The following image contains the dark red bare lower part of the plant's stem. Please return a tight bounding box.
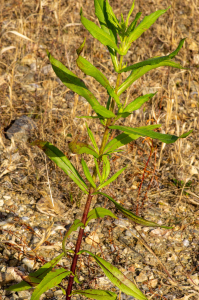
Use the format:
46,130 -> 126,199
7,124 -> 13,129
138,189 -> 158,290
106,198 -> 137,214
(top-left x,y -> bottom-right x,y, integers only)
66,190 -> 93,300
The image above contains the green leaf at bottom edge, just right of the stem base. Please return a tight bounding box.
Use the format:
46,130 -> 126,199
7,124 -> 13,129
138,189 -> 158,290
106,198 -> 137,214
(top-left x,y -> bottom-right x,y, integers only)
72,289 -> 117,300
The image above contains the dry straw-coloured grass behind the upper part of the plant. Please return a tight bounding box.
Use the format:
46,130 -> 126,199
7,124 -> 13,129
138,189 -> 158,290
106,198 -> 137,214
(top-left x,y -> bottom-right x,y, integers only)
0,0 -> 199,300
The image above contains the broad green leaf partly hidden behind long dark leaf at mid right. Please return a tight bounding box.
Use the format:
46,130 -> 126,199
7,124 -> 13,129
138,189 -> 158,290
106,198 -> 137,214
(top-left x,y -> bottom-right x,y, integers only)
104,124 -> 161,154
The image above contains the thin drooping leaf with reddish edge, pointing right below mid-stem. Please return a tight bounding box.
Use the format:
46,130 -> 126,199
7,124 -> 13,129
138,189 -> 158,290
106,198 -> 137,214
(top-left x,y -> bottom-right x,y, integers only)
98,192 -> 172,229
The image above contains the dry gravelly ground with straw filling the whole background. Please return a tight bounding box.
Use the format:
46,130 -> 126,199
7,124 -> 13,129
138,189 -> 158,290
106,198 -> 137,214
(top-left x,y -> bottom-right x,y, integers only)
0,0 -> 199,300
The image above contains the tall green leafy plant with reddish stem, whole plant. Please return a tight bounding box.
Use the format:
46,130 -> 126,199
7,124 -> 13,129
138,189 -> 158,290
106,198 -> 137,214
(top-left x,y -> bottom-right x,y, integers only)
9,0 -> 191,300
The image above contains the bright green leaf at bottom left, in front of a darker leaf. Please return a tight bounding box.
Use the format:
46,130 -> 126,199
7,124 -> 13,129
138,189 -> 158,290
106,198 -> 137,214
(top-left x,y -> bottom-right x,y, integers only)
31,268 -> 72,300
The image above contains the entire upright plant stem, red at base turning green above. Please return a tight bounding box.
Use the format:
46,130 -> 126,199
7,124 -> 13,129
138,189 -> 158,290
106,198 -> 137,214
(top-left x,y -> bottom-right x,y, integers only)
66,56 -> 123,300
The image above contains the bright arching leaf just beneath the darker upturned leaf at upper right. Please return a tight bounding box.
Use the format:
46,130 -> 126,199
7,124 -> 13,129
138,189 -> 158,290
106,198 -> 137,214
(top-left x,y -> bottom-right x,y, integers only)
117,60 -> 186,96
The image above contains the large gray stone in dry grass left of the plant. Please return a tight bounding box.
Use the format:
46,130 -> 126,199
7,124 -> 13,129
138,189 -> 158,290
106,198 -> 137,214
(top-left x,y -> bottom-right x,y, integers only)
6,116 -> 37,142
